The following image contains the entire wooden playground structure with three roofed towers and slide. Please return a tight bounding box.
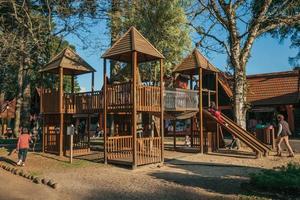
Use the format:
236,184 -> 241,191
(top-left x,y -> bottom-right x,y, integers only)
40,27 -> 270,168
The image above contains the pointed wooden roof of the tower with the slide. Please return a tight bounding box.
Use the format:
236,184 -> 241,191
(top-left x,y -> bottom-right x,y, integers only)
173,48 -> 219,75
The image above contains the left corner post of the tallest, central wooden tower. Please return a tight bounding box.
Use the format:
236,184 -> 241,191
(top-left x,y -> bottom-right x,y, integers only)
103,59 -> 107,164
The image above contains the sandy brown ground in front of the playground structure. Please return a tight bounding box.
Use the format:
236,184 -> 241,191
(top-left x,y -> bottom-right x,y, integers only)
0,145 -> 300,200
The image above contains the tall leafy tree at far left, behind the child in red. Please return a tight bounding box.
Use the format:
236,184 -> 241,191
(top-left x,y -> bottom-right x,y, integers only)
0,0 -> 106,135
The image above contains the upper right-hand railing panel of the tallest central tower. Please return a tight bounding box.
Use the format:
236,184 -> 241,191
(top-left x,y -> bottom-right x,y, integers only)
137,86 -> 160,112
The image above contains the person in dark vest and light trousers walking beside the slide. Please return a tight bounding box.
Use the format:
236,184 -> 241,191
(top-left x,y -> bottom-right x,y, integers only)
277,115 -> 294,157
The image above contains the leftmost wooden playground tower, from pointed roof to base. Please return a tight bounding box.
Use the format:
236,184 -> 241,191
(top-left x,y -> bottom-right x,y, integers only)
40,48 -> 96,155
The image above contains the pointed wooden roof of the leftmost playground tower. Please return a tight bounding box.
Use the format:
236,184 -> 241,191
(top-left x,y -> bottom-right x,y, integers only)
40,47 -> 96,75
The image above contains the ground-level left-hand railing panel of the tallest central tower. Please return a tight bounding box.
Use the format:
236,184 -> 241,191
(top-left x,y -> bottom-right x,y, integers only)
106,135 -> 133,161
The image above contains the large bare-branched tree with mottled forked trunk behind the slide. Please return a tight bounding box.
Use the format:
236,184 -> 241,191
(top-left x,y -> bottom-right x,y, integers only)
189,0 -> 300,128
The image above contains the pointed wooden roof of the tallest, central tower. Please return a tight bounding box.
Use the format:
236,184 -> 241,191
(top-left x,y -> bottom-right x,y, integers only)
102,26 -> 165,63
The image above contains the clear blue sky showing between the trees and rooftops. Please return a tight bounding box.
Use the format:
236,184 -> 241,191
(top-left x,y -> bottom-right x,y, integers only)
66,23 -> 297,92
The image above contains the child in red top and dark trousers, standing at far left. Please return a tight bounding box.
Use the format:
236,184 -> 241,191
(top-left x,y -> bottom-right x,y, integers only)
17,128 -> 31,166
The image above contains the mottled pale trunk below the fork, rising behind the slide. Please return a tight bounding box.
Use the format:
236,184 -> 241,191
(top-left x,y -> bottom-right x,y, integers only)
233,69 -> 247,129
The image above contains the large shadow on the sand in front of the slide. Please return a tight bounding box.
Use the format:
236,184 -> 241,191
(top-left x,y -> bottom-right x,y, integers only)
149,159 -> 270,198
